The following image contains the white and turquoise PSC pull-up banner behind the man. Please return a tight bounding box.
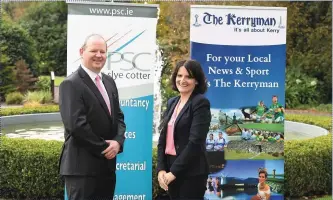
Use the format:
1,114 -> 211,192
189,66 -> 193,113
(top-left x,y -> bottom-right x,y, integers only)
67,2 -> 158,200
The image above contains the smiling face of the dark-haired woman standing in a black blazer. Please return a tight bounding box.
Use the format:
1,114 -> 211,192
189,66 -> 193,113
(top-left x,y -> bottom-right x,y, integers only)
176,66 -> 197,94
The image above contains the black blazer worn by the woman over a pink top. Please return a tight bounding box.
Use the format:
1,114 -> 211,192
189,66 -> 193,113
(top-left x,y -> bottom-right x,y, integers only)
157,93 -> 211,178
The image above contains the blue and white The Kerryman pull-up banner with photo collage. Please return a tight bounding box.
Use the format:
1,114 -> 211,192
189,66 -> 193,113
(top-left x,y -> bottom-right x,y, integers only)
190,5 -> 287,200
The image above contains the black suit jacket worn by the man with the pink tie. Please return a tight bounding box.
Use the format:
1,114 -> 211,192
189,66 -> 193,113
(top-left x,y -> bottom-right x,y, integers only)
59,67 -> 126,176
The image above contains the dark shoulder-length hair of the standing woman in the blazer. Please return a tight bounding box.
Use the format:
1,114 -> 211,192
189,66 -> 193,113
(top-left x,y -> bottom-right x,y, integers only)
171,60 -> 207,94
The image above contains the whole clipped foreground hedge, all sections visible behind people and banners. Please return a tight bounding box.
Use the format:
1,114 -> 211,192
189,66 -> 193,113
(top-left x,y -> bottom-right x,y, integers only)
0,134 -> 332,199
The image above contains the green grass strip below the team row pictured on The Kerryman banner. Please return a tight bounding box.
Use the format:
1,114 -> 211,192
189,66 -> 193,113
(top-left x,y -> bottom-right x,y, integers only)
224,148 -> 284,160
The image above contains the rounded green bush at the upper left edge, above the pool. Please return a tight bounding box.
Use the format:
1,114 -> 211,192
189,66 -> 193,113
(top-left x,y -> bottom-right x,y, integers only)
0,12 -> 38,74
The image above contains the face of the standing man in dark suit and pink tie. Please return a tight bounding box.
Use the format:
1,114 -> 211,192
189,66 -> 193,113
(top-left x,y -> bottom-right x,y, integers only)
80,37 -> 106,73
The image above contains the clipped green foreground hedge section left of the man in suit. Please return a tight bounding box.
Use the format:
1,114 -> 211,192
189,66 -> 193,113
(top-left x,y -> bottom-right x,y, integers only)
0,136 -> 63,199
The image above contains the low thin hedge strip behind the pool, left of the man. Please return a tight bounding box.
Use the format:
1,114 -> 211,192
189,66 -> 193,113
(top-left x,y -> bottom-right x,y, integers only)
0,105 -> 59,116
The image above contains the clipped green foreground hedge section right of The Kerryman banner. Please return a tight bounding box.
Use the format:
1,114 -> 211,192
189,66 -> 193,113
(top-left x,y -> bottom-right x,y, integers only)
284,134 -> 332,197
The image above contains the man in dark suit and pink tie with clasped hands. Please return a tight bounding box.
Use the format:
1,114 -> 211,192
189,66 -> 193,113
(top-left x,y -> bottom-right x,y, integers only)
59,34 -> 126,200
